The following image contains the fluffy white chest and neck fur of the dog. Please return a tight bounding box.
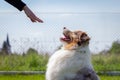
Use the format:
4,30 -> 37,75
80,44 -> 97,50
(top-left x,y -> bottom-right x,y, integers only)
46,46 -> 93,80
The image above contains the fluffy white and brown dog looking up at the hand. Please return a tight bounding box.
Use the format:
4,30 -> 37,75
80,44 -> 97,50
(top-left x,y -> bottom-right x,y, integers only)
46,27 -> 99,80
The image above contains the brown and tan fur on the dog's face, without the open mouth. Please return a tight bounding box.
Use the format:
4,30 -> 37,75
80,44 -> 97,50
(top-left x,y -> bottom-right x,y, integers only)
63,28 -> 90,50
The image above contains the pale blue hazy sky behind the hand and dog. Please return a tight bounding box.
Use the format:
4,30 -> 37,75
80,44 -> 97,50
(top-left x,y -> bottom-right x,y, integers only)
0,0 -> 120,53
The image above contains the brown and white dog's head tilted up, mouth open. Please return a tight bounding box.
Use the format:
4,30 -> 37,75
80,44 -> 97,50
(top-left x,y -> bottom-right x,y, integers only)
60,27 -> 90,49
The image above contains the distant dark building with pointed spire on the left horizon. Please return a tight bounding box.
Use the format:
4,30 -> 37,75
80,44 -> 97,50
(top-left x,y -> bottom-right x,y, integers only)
2,34 -> 11,54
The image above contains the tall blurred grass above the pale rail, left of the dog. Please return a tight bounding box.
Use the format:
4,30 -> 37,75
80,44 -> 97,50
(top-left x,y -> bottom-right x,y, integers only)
0,53 -> 48,71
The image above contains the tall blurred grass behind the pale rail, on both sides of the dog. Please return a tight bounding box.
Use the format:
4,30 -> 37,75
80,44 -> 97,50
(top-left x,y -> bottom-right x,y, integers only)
0,53 -> 120,71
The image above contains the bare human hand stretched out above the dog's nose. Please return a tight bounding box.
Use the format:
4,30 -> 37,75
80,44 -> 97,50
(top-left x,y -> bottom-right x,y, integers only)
23,6 -> 43,23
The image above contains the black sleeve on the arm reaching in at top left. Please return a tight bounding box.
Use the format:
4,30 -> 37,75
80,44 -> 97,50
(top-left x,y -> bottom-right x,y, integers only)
5,0 -> 26,11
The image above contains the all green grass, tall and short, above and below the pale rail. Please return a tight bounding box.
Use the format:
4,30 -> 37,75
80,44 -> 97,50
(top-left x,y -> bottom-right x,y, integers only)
0,47 -> 120,80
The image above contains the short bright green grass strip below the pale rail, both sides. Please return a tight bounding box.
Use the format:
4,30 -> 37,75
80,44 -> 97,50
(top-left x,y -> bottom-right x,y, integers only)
0,75 -> 120,80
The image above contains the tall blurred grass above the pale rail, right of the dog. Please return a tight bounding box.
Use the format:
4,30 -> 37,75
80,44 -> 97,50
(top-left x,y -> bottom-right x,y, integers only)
92,54 -> 120,71
